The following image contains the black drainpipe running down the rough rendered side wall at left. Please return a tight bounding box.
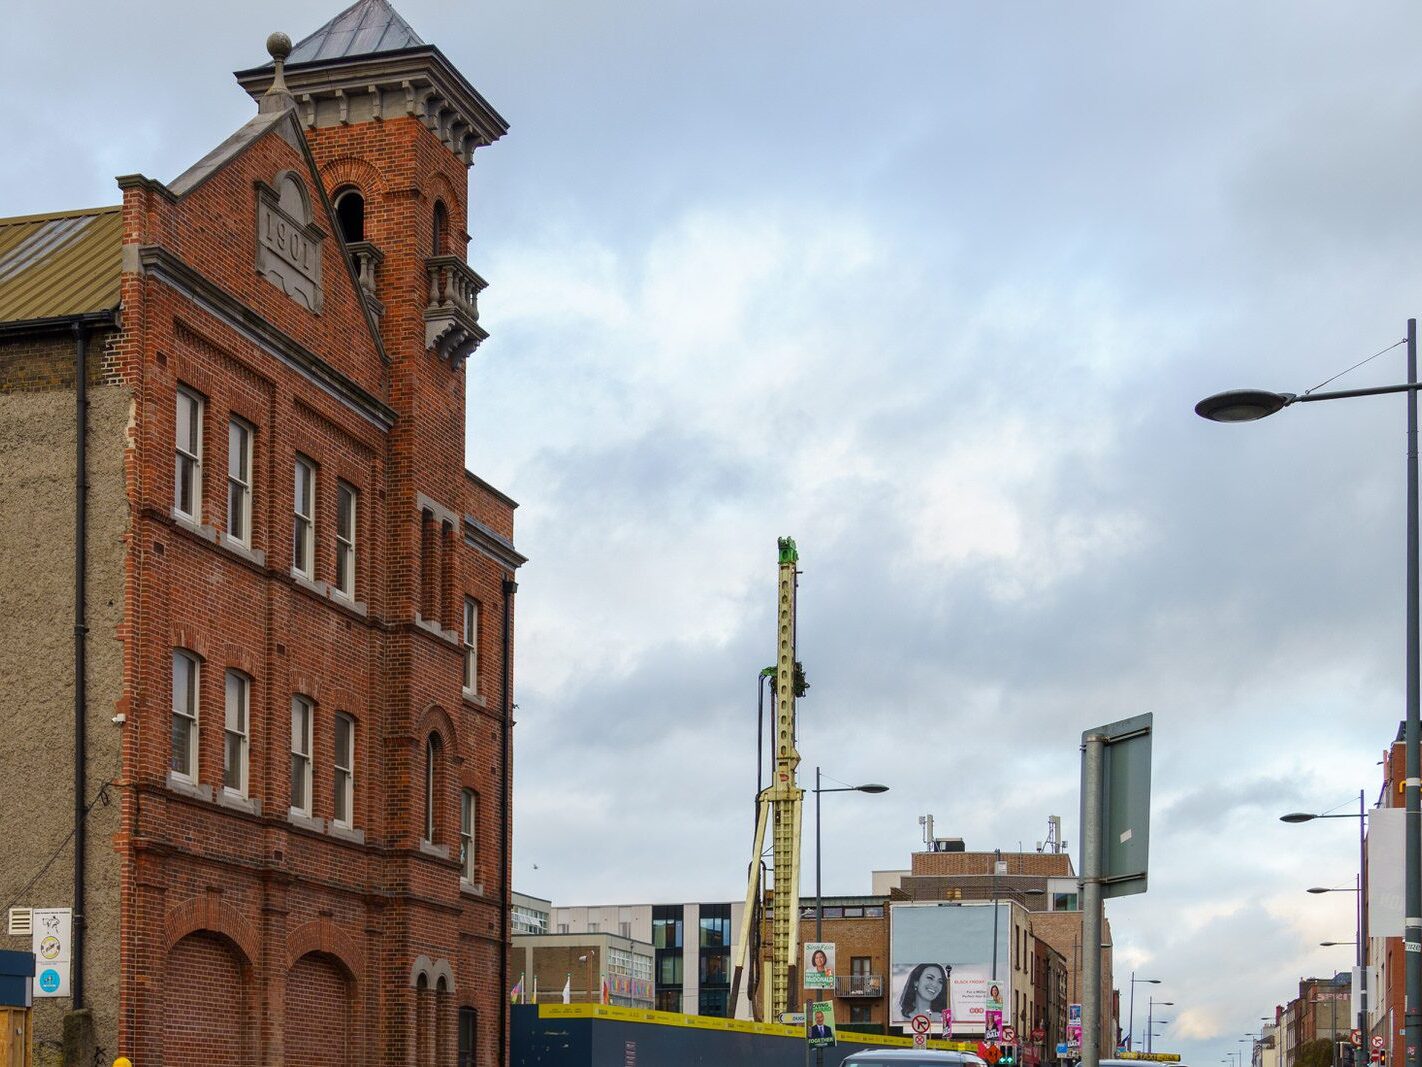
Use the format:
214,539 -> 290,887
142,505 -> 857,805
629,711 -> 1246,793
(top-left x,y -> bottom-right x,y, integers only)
70,322 -> 88,1012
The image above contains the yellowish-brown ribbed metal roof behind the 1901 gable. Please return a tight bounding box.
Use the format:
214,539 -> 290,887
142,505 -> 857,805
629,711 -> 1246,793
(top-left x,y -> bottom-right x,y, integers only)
0,208 -> 124,322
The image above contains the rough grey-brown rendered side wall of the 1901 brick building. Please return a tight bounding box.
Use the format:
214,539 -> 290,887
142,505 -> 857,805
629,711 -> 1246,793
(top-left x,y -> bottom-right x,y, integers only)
0,355 -> 129,1064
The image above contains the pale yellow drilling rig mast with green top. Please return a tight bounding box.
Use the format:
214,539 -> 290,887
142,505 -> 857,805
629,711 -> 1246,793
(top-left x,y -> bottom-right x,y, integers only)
731,538 -> 805,1019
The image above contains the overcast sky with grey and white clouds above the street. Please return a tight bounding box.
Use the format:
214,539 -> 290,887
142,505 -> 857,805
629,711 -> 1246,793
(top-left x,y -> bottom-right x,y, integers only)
0,0 -> 1422,1067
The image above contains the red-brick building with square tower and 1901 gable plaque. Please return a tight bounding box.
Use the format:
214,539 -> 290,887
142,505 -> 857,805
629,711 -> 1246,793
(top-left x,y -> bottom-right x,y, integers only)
0,0 -> 523,1067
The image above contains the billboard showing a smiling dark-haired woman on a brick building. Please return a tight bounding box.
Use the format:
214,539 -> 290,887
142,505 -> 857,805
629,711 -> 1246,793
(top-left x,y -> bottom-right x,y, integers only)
889,902 -> 1012,1034
